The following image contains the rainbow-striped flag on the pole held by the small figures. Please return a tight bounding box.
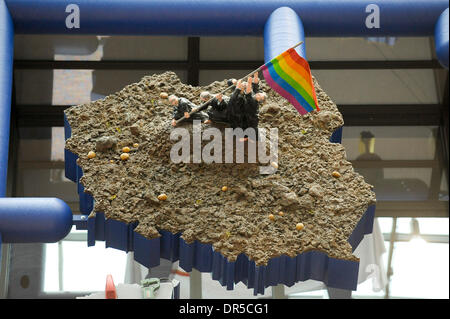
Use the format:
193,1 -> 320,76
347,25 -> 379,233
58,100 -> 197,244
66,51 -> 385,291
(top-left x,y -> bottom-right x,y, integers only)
261,48 -> 319,115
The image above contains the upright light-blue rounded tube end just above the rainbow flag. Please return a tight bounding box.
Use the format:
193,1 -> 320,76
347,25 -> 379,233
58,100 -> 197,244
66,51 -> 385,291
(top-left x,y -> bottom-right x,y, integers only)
264,7 -> 306,62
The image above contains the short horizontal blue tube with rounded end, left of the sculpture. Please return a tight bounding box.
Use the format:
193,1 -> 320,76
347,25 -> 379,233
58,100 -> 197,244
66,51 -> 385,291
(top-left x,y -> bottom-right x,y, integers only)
0,197 -> 72,243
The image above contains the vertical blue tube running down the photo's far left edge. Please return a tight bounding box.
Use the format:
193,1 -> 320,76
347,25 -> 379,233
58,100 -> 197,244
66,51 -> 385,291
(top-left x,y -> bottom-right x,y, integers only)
0,1 -> 14,197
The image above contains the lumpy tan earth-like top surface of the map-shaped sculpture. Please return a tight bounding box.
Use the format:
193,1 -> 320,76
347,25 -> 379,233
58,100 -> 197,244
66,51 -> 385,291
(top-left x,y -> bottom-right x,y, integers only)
66,72 -> 375,265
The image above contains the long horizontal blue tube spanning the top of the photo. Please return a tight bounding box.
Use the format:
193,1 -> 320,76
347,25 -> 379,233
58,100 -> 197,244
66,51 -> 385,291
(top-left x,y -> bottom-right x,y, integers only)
5,0 -> 448,37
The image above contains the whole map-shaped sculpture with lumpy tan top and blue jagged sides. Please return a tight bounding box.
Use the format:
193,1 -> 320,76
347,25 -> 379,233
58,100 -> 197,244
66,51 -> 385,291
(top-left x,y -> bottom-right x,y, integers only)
65,72 -> 375,294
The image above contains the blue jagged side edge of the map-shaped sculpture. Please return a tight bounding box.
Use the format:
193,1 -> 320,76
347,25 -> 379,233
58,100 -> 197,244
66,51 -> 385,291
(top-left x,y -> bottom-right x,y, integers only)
64,114 -> 375,296
